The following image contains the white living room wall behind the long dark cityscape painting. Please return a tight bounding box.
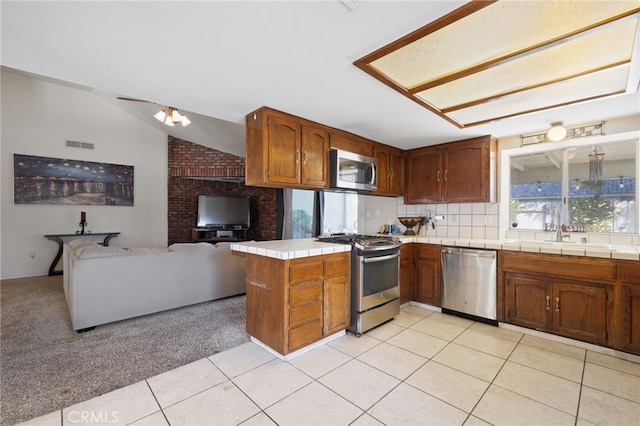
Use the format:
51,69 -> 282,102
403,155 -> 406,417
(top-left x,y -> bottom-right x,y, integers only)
0,69 -> 167,279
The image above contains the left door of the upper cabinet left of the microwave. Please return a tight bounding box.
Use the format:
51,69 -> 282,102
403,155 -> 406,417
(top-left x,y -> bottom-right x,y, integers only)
264,114 -> 302,184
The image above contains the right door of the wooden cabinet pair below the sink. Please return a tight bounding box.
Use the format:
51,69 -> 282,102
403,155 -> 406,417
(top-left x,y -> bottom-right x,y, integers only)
552,282 -> 607,345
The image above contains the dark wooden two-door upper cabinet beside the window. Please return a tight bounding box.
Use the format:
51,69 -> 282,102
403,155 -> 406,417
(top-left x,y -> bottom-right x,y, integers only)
404,136 -> 497,204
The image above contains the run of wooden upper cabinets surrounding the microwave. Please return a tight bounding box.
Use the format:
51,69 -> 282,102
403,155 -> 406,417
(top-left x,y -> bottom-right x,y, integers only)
245,107 -> 404,195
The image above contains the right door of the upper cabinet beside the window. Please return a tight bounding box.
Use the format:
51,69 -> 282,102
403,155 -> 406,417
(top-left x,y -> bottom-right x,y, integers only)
443,137 -> 489,203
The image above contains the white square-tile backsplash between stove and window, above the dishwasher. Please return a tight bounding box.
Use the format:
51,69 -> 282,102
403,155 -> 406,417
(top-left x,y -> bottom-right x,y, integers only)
397,197 -> 503,240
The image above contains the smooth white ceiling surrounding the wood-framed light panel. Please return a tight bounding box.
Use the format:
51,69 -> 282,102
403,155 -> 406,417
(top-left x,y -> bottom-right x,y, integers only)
1,0 -> 640,152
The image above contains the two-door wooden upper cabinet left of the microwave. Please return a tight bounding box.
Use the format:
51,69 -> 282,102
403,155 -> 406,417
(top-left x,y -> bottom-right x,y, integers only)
245,108 -> 329,188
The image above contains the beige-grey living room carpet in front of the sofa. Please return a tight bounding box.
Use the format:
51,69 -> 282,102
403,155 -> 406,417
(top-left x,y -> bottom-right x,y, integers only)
0,276 -> 249,425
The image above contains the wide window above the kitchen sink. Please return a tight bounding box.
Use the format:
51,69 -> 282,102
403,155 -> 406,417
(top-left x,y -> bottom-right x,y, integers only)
503,135 -> 638,233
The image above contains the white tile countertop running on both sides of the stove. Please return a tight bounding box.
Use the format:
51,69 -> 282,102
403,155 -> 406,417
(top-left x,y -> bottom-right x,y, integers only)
231,235 -> 640,260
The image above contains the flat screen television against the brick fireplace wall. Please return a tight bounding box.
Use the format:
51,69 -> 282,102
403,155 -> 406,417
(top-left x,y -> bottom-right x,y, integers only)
198,195 -> 250,228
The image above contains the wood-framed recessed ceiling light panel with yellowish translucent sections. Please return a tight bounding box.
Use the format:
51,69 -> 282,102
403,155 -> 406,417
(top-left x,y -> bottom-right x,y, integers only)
354,0 -> 640,128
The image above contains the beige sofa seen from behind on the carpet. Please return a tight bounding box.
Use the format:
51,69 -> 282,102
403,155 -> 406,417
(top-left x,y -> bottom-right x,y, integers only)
63,239 -> 246,330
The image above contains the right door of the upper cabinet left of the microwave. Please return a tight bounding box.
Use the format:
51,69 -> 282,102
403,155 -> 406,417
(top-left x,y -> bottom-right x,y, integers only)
300,125 -> 329,188
